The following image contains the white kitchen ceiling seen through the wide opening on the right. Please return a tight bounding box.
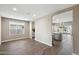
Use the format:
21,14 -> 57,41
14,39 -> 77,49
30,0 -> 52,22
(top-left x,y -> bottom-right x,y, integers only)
52,10 -> 73,23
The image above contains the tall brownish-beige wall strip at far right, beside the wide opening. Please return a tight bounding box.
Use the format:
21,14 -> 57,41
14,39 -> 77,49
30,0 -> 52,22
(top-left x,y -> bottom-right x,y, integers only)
72,5 -> 79,54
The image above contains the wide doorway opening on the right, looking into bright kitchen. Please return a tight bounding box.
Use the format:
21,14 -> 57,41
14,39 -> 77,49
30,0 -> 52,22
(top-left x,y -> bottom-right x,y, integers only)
52,10 -> 73,54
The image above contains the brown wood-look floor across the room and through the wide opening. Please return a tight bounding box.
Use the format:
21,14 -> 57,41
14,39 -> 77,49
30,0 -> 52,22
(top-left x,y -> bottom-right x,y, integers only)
0,35 -> 73,55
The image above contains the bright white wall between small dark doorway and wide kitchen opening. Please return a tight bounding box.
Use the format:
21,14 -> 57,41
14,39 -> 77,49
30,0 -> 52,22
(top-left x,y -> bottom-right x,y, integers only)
35,16 -> 52,46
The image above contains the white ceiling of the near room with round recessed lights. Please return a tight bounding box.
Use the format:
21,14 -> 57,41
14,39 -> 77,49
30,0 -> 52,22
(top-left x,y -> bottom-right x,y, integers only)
0,4 -> 74,21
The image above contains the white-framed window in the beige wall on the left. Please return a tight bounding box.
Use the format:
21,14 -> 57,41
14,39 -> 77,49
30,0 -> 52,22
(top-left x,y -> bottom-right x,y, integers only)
9,22 -> 24,35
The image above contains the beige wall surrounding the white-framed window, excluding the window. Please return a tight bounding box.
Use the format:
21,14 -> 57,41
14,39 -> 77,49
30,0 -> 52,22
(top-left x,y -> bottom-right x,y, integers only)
1,18 -> 29,42
